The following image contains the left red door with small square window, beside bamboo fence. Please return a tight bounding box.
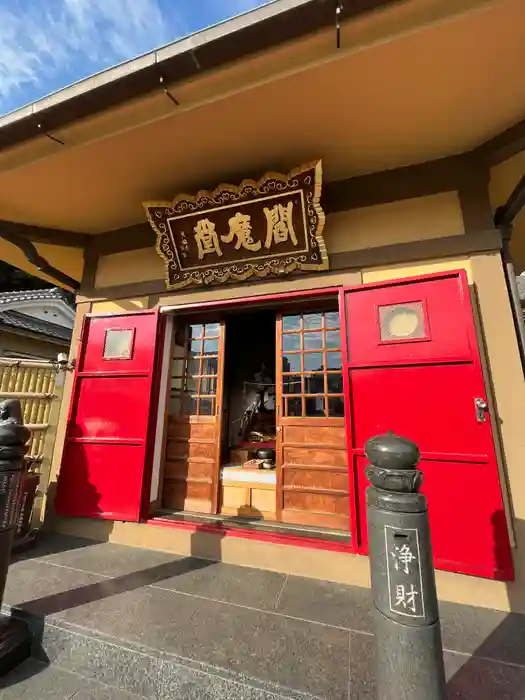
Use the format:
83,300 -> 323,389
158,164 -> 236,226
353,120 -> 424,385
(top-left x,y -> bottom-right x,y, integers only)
55,311 -> 159,521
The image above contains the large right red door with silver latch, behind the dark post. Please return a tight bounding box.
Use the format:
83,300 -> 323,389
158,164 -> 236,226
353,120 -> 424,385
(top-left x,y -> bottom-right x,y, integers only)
343,271 -> 513,580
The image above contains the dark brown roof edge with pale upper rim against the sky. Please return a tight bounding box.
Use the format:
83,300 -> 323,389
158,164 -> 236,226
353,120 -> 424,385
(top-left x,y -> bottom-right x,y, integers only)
0,0 -> 400,151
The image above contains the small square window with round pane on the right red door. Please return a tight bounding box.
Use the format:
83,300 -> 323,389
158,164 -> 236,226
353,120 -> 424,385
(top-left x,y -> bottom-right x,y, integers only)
377,301 -> 430,343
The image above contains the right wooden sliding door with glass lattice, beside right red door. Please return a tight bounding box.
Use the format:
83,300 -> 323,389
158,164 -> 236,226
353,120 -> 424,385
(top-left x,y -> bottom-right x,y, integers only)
277,311 -> 349,531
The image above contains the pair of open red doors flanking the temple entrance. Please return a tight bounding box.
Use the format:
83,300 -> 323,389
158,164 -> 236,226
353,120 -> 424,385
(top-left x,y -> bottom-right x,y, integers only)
56,272 -> 513,579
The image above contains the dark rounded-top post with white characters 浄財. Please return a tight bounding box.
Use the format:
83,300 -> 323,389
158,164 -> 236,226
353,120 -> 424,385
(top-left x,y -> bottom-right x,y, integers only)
365,432 -> 446,700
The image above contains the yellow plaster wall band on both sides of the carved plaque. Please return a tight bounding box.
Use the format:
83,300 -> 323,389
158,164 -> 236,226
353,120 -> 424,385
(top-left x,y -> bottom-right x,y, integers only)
95,192 -> 465,288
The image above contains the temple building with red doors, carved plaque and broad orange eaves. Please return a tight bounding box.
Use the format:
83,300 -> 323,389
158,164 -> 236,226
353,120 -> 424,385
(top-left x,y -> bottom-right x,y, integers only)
0,0 -> 525,612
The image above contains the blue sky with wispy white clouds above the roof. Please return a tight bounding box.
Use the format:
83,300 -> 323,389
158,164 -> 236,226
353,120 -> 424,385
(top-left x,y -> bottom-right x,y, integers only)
0,0 -> 269,114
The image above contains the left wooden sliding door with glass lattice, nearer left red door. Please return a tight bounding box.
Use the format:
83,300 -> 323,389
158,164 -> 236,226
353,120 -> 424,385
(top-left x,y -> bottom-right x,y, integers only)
162,322 -> 224,513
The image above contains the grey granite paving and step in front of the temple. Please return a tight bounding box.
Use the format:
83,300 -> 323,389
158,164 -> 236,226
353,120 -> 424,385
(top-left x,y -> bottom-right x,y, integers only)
0,535 -> 525,700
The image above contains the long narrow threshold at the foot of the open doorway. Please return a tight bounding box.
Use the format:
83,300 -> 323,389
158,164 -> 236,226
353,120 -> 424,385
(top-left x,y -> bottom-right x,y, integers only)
149,510 -> 352,548
